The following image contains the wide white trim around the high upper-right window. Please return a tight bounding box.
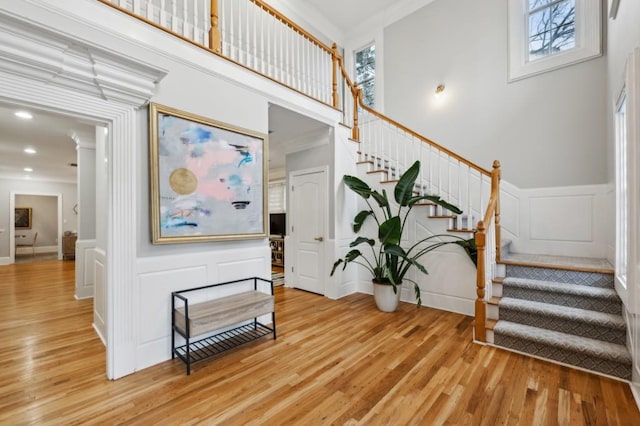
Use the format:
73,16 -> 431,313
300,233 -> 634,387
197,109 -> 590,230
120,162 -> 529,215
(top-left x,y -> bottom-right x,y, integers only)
508,0 -> 602,82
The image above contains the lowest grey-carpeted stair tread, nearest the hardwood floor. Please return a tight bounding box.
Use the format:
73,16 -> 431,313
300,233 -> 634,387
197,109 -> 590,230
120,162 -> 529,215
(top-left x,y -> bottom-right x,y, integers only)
493,320 -> 631,365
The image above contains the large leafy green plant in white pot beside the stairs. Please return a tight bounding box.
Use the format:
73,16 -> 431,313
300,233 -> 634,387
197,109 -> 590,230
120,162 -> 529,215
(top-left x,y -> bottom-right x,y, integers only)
331,161 -> 475,312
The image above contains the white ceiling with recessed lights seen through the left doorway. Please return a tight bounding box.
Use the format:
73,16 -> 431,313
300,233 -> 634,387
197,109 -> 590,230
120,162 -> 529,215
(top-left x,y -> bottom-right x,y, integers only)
0,104 -> 95,182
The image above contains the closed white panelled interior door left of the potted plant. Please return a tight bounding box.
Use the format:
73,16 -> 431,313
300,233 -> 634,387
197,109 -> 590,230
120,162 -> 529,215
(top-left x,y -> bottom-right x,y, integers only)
290,170 -> 328,295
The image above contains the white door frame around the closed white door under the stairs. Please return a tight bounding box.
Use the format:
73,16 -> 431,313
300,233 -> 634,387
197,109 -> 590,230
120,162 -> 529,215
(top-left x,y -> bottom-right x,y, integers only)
285,165 -> 331,297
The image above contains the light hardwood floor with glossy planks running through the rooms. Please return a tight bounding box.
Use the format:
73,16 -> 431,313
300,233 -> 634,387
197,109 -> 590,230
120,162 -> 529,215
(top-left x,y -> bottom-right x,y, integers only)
0,261 -> 640,425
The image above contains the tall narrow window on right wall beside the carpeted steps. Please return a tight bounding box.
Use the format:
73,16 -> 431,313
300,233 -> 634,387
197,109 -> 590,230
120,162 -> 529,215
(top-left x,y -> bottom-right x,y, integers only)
615,90 -> 629,289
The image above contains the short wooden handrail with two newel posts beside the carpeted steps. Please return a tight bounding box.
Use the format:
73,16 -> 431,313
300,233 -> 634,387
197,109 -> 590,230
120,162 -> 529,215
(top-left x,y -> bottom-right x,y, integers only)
474,160 -> 501,342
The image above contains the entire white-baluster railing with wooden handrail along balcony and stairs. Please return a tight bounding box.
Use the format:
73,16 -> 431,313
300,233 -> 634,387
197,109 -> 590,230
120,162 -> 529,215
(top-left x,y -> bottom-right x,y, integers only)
98,0 -> 500,341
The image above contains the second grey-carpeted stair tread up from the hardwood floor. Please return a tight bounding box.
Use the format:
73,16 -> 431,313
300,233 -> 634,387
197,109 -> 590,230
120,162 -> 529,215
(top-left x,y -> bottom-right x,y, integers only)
498,297 -> 626,330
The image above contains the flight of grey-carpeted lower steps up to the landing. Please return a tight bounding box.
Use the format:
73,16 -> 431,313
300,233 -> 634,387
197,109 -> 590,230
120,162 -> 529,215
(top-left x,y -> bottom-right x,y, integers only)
487,250 -> 632,380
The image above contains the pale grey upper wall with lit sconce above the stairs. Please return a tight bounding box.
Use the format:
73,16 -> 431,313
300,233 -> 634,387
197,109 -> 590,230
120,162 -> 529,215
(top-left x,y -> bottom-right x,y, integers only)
383,0 -> 606,188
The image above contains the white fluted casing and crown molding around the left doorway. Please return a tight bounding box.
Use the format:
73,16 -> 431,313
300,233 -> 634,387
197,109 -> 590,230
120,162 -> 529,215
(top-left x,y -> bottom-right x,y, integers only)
0,9 -> 167,379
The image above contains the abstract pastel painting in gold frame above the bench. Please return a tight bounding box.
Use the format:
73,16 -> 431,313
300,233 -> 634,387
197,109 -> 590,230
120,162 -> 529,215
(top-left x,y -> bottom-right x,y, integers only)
149,103 -> 268,244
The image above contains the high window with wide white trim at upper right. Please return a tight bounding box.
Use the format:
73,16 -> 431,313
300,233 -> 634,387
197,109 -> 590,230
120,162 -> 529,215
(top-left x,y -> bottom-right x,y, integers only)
509,0 -> 602,81
